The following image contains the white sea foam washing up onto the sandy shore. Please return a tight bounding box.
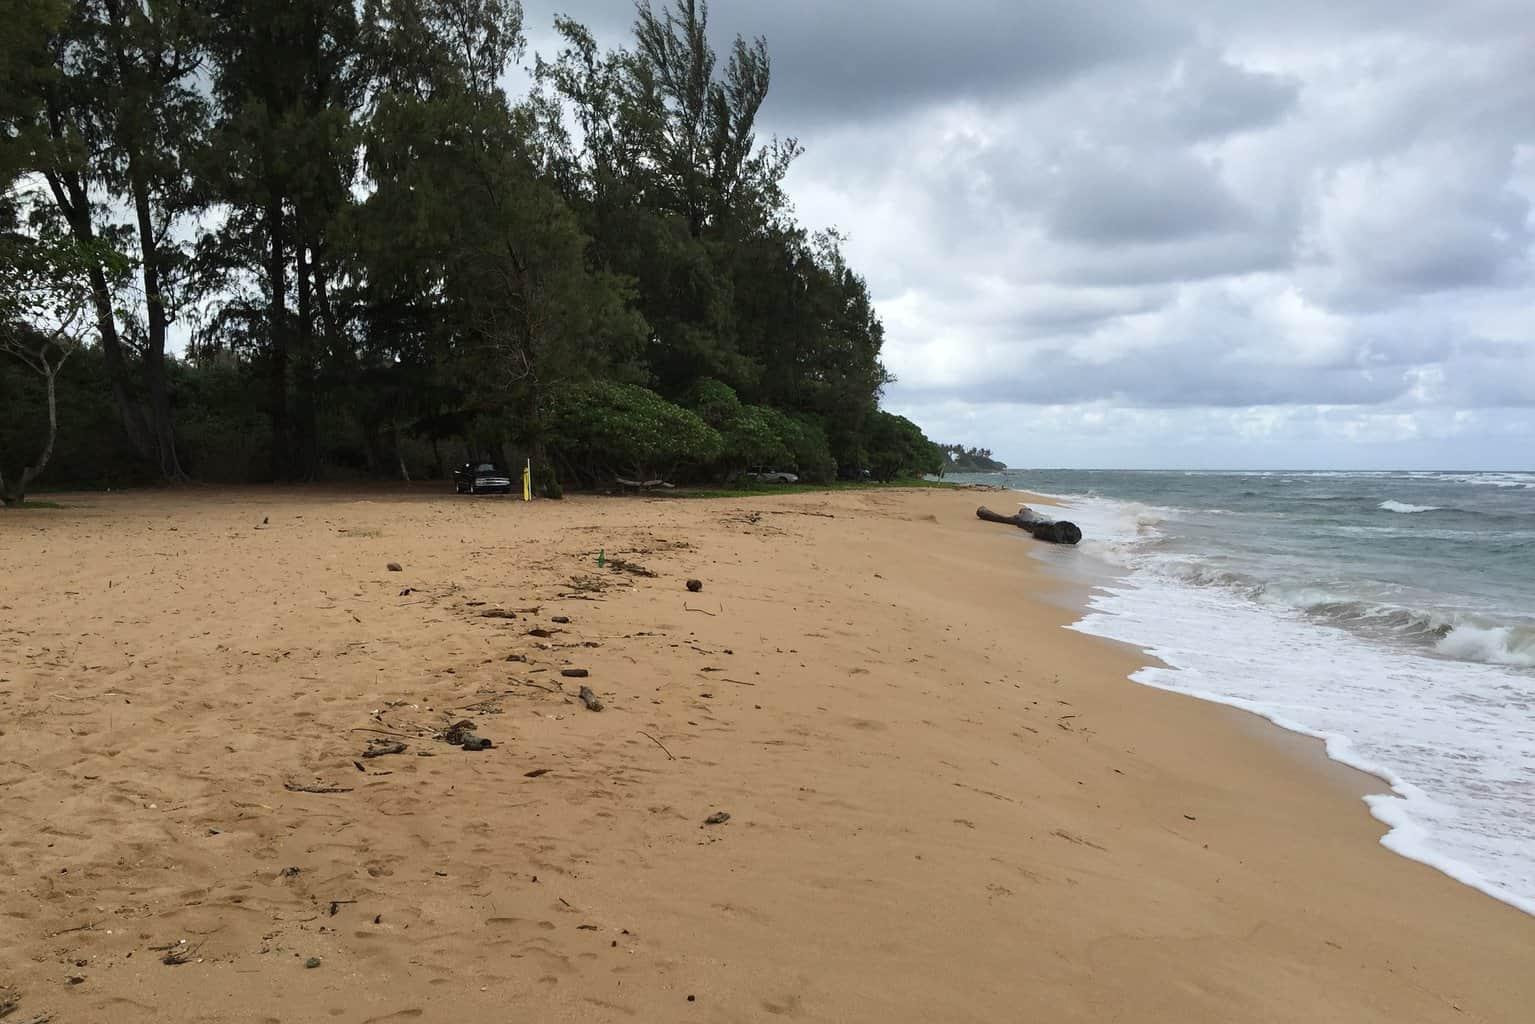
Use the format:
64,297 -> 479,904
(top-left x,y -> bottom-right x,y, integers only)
1049,499 -> 1535,915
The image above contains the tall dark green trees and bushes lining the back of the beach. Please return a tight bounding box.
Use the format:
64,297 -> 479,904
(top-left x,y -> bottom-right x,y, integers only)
0,0 -> 942,500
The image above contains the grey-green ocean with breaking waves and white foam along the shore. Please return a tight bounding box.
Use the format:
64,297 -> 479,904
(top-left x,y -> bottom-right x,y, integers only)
955,470 -> 1535,913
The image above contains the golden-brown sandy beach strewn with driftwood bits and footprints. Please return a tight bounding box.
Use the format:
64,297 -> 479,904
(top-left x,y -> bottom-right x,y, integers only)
0,490 -> 1535,1024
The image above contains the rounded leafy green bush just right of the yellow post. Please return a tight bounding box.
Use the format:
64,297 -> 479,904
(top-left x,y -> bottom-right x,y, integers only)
545,381 -> 723,484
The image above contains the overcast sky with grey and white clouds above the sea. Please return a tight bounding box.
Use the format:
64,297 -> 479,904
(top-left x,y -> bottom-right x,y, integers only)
527,0 -> 1535,468
